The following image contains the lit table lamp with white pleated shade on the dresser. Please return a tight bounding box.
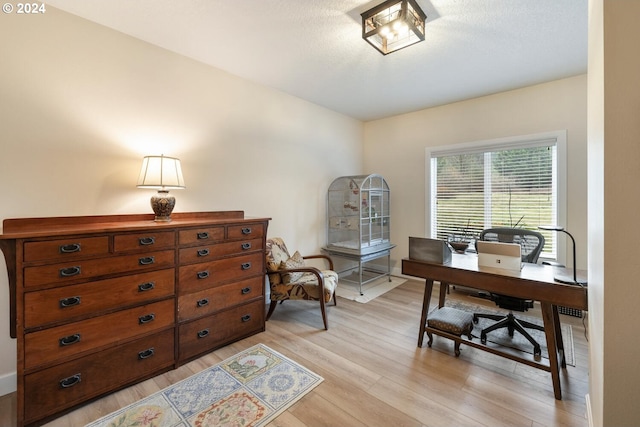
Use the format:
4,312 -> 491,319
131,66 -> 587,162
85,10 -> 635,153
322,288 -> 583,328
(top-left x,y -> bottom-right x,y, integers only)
137,154 -> 185,222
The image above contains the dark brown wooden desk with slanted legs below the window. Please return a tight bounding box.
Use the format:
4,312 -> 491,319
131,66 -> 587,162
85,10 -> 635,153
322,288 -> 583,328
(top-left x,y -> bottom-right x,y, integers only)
402,254 -> 588,400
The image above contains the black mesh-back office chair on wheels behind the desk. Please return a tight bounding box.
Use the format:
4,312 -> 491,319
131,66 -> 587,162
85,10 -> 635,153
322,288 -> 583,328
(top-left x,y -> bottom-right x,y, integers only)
473,228 -> 544,356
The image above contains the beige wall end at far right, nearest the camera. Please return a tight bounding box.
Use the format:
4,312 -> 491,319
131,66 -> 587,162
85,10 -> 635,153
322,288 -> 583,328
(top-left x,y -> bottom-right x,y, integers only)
589,0 -> 640,426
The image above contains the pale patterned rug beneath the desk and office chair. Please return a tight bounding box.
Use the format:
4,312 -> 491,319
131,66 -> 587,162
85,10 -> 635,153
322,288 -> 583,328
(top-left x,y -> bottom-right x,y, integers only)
444,300 -> 576,366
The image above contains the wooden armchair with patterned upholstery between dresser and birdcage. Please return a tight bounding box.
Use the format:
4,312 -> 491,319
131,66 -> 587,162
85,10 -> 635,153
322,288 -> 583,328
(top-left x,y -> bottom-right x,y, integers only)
266,237 -> 338,329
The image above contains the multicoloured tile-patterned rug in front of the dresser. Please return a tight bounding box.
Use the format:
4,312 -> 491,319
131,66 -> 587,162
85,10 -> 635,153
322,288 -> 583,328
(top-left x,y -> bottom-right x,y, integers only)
85,344 -> 323,427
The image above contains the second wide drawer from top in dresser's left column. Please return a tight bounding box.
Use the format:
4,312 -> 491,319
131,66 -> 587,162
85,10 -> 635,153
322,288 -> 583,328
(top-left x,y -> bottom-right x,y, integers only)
24,268 -> 175,329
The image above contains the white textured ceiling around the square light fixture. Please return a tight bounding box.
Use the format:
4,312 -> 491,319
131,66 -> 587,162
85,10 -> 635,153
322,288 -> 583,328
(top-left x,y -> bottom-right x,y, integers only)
46,0 -> 588,121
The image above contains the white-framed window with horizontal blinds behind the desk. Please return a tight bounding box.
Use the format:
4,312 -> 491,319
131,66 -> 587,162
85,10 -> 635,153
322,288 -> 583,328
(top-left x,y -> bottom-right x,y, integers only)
426,131 -> 566,259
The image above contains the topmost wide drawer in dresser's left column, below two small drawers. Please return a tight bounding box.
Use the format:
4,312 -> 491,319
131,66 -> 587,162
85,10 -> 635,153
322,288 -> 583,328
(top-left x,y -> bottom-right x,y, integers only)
24,250 -> 175,288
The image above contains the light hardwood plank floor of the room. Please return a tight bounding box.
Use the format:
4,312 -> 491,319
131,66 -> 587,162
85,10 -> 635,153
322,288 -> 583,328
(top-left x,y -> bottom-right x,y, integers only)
0,280 -> 588,427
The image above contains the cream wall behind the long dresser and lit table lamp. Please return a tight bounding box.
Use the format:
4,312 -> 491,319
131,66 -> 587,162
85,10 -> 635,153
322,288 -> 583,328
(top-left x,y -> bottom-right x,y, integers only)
0,7 -> 363,395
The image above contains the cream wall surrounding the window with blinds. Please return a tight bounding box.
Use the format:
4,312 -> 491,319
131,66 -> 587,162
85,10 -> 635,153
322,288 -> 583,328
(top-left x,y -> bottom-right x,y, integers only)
364,75 -> 587,271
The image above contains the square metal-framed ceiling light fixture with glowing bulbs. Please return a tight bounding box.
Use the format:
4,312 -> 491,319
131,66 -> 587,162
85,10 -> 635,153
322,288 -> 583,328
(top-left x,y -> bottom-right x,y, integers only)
361,0 -> 427,55
